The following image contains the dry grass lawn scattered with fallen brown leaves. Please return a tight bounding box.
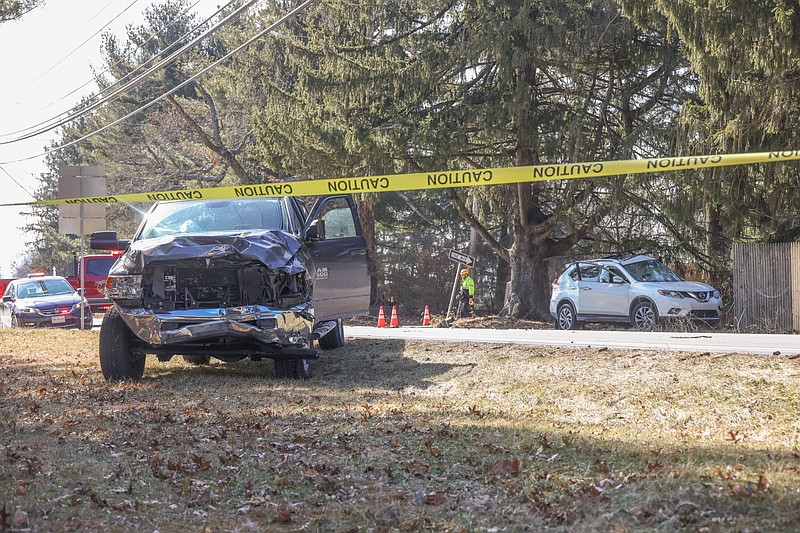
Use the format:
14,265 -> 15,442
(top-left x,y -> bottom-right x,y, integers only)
0,329 -> 800,532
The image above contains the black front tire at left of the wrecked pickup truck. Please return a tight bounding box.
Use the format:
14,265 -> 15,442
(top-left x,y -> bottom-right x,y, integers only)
100,307 -> 145,381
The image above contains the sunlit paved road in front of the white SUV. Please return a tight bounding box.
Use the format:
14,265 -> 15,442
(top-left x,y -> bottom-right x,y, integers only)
345,326 -> 800,355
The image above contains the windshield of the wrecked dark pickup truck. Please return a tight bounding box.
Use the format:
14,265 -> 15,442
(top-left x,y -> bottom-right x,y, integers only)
138,198 -> 289,239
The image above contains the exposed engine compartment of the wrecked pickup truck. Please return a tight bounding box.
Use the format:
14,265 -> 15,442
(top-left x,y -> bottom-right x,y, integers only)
142,264 -> 311,311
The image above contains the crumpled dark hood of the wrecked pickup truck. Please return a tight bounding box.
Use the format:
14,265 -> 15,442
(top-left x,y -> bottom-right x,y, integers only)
109,230 -> 313,276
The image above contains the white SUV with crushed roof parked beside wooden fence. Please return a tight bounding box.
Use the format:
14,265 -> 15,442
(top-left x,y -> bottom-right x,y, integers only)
550,255 -> 722,330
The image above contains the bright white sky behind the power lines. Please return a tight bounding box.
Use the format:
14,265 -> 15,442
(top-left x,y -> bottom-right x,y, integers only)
0,0 -> 220,277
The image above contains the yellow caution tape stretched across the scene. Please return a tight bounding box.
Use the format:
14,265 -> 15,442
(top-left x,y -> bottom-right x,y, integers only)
6,150 -> 800,206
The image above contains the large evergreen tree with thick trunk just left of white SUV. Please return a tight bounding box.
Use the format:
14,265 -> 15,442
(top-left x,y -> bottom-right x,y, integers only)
248,0 -> 686,318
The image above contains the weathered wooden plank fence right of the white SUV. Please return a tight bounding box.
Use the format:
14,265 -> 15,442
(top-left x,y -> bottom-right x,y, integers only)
733,242 -> 800,331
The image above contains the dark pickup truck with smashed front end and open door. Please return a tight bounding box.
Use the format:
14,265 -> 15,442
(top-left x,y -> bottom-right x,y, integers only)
91,195 -> 370,380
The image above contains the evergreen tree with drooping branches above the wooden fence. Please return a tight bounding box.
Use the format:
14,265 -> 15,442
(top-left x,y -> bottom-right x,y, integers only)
620,0 -> 800,266
